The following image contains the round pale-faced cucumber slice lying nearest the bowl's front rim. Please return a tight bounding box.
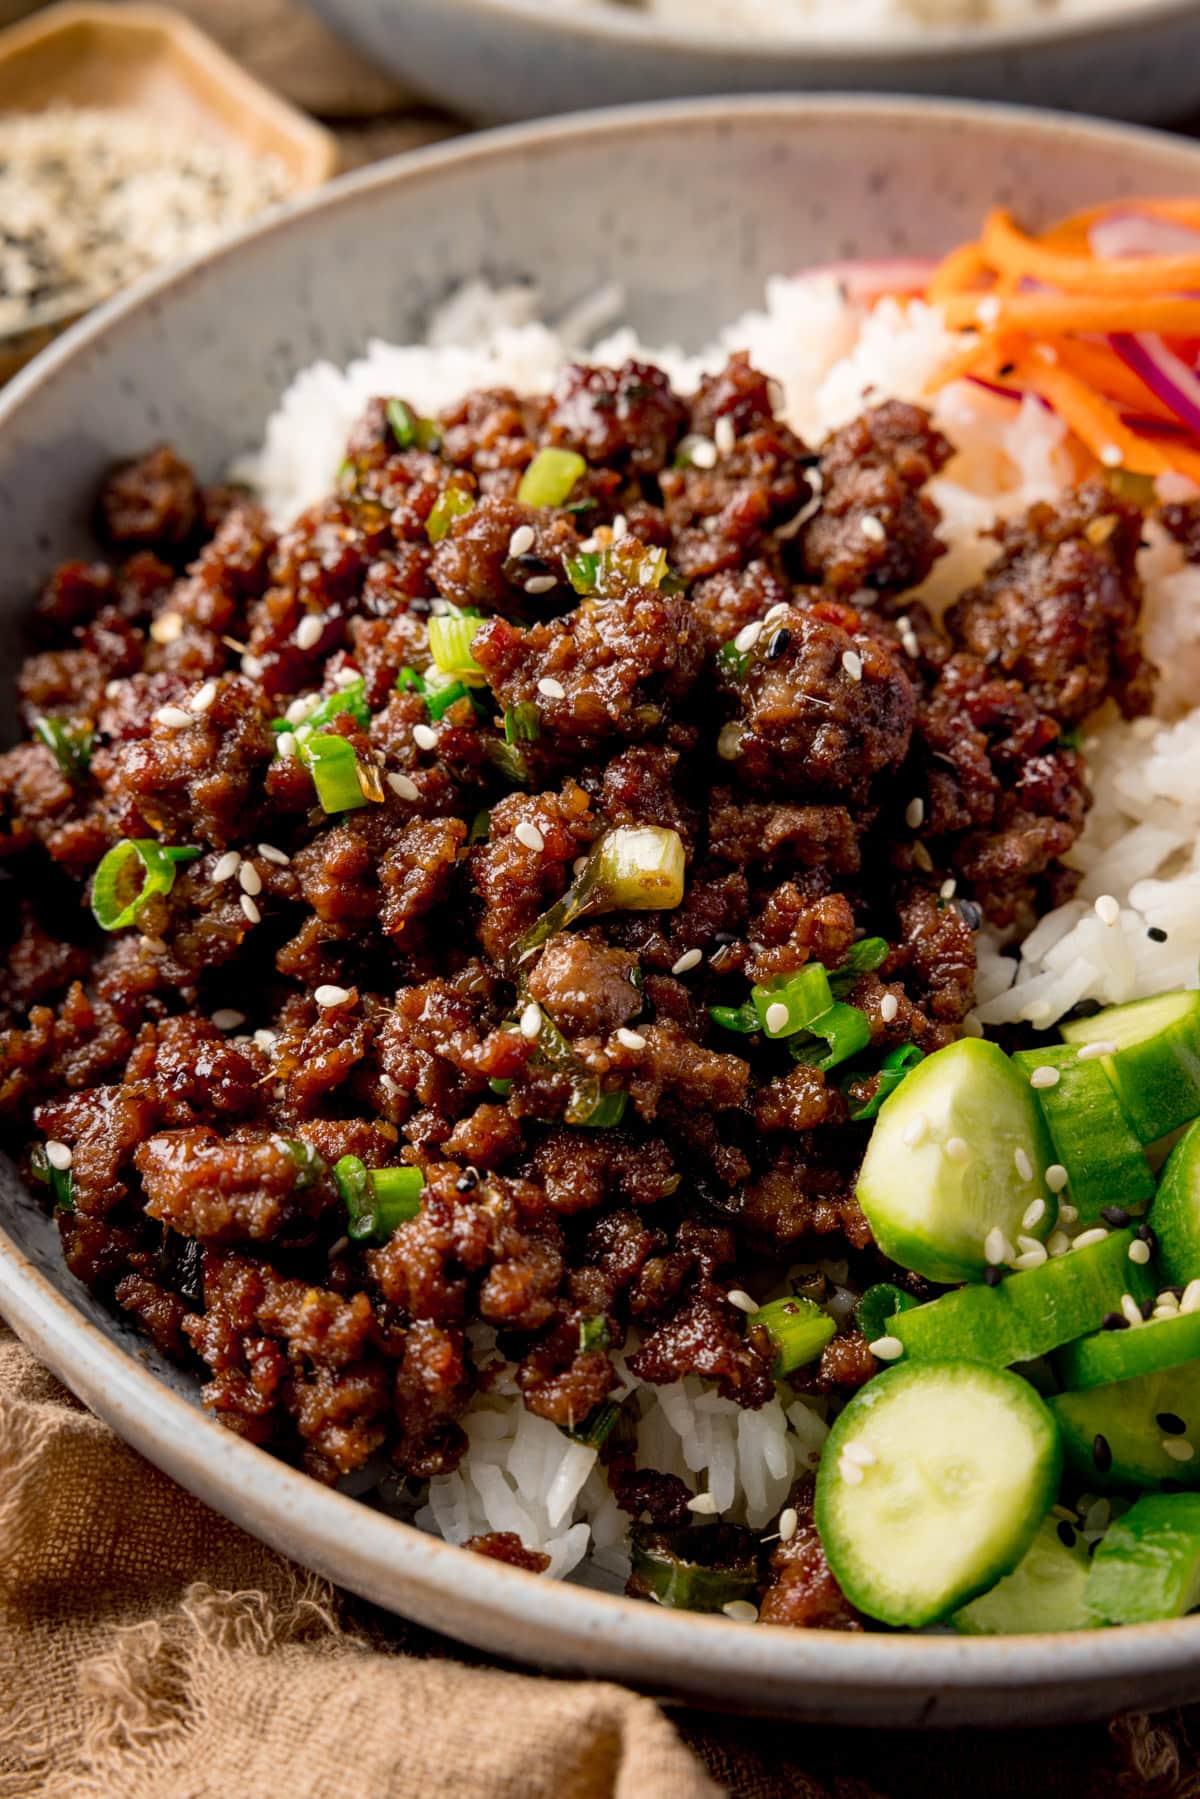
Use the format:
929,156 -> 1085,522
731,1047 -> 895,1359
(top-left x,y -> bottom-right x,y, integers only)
815,1362 -> 1061,1628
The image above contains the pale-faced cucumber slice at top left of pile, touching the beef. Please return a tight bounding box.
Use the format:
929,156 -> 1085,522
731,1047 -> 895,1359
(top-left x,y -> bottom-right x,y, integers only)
858,1038 -> 1058,1281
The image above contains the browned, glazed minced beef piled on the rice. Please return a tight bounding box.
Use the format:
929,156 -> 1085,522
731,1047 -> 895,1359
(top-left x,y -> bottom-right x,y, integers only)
0,356 -> 1151,1628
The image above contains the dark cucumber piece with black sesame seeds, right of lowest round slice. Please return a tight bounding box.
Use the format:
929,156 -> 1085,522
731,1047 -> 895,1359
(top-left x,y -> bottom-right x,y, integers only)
1047,1364 -> 1200,1493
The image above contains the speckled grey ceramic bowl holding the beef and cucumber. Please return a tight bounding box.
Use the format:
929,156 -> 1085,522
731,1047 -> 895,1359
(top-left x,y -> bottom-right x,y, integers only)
0,99 -> 1200,1725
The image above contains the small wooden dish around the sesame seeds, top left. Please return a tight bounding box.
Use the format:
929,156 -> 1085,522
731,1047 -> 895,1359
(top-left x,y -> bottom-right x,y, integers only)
0,0 -> 338,381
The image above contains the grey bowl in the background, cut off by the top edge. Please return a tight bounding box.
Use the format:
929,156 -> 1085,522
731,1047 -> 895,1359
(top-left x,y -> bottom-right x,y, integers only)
313,0 -> 1200,121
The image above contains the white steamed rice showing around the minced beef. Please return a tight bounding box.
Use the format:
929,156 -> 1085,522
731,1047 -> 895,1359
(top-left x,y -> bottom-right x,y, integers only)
239,277 -> 1200,1585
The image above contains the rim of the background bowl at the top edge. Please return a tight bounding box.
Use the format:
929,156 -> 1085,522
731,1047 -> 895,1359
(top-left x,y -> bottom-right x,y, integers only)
379,0 -> 1196,74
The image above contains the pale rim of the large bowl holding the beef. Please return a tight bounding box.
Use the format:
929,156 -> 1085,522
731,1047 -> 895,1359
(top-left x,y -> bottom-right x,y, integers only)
0,94 -> 1200,1698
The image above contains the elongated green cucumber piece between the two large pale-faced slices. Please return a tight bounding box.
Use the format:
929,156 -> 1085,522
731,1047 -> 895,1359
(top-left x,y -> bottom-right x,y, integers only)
889,1231 -> 1157,1367
